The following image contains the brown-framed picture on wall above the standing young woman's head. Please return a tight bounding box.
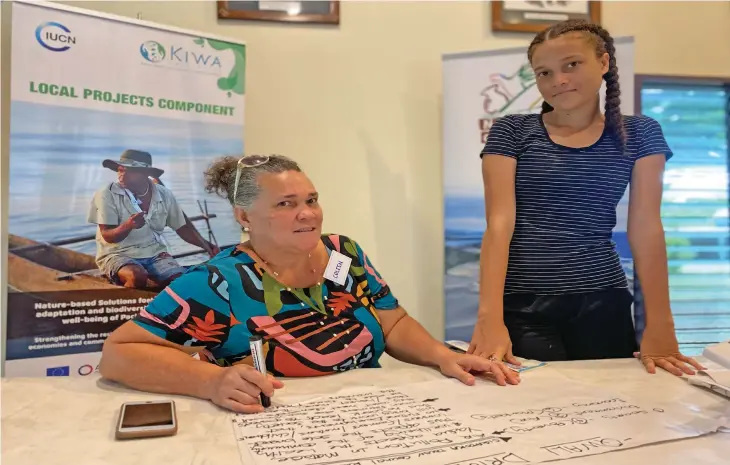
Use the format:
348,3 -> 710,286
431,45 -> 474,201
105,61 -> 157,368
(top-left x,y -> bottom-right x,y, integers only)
492,0 -> 601,33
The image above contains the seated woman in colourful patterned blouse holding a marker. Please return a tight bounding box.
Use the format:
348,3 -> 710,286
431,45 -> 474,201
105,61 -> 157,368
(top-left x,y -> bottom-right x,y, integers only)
99,155 -> 519,413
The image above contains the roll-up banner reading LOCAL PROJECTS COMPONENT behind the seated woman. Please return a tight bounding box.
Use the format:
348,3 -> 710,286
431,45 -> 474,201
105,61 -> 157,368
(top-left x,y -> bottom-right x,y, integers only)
5,2 -> 246,377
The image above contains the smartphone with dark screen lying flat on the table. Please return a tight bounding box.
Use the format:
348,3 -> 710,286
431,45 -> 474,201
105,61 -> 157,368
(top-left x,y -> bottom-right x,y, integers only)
115,400 -> 177,439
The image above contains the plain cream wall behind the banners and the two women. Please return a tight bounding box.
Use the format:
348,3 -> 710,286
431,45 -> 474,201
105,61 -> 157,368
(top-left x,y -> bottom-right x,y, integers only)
2,0 -> 730,348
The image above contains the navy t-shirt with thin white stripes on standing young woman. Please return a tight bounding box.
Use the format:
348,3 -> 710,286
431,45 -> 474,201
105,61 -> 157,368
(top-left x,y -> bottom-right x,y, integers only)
480,114 -> 672,295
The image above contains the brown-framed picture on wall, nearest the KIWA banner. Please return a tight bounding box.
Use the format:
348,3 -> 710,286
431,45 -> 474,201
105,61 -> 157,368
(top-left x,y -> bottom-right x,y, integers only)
218,0 -> 340,24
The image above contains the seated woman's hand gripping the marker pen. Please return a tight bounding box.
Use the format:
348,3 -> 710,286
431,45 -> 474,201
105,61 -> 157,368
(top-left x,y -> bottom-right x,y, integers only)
206,365 -> 284,413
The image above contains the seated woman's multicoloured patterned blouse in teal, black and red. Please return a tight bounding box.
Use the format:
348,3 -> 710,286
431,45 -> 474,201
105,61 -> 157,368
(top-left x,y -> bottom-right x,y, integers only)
134,234 -> 398,377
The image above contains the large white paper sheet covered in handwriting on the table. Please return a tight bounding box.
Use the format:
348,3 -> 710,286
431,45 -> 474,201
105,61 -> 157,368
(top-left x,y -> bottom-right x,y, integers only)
233,376 -> 730,465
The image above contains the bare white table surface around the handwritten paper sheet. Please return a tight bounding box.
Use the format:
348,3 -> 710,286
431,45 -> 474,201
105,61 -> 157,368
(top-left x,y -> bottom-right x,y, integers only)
1,358 -> 730,465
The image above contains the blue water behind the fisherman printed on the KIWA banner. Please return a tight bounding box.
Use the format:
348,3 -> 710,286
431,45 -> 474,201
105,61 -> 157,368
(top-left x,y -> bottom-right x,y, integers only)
8,101 -> 244,264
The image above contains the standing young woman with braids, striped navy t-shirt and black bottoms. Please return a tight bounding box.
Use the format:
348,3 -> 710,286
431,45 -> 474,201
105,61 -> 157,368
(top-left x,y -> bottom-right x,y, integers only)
469,20 -> 701,376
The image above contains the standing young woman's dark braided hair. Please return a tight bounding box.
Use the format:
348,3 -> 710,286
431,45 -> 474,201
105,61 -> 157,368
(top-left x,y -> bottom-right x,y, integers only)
527,19 -> 626,151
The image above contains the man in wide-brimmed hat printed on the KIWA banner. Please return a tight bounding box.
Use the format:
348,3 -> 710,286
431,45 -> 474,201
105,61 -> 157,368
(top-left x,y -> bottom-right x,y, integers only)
87,150 -> 219,289
